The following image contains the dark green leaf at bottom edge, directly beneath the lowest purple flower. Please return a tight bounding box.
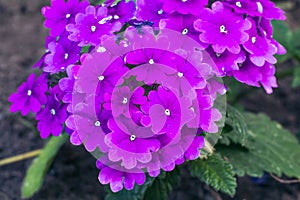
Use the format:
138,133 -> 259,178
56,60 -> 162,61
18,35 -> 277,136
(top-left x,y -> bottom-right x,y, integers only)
105,177 -> 154,200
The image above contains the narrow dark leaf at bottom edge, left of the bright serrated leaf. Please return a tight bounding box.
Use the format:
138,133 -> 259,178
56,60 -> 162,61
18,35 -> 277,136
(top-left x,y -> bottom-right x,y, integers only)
144,168 -> 180,200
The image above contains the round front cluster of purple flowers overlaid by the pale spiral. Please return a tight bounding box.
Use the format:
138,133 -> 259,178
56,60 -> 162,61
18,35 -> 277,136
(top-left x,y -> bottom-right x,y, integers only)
66,28 -> 226,192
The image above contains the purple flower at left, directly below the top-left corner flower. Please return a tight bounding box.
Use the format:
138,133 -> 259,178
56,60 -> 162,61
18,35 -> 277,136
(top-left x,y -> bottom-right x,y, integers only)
44,35 -> 81,74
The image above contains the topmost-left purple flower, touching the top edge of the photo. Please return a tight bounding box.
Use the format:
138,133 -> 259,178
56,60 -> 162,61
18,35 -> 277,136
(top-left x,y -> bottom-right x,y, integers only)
42,0 -> 89,37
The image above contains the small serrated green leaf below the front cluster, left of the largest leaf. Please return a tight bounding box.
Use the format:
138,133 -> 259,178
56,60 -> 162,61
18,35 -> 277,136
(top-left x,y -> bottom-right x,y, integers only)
190,153 -> 237,196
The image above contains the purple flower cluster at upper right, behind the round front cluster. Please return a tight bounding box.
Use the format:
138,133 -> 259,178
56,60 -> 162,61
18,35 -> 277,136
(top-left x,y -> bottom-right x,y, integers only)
137,0 -> 286,93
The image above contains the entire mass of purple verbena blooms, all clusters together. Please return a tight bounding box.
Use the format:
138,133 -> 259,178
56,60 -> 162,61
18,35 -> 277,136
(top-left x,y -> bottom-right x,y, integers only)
9,0 -> 285,192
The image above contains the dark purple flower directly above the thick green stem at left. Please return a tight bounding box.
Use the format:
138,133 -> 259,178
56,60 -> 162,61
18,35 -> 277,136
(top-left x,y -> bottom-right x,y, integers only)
36,90 -> 67,138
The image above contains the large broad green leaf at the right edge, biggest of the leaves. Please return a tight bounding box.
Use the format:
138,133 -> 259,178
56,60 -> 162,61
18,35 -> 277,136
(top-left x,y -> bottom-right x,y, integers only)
216,113 -> 300,178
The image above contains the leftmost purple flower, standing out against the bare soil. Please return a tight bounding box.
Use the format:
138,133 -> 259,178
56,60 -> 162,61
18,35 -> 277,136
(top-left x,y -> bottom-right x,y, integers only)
8,74 -> 48,115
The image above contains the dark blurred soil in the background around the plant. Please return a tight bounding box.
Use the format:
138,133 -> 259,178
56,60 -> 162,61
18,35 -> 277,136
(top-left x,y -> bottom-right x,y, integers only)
0,0 -> 300,200
